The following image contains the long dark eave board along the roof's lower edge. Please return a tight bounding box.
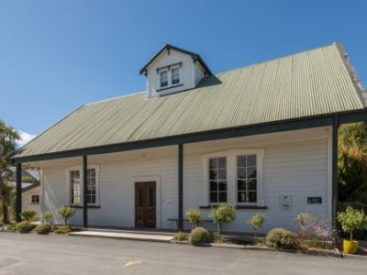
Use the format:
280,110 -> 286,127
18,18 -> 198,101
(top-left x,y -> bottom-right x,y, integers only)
11,109 -> 367,163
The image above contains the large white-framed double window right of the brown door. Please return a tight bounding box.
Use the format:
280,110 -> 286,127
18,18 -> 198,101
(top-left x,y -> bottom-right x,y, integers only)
202,149 -> 265,207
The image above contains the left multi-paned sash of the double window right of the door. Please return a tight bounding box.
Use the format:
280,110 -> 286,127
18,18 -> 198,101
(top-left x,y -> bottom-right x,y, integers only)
209,157 -> 227,204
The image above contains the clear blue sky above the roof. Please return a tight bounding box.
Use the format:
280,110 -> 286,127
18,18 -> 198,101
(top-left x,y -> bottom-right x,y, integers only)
0,0 -> 367,141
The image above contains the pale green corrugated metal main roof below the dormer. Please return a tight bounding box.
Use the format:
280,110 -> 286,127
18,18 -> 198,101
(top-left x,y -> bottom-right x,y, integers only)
16,44 -> 365,157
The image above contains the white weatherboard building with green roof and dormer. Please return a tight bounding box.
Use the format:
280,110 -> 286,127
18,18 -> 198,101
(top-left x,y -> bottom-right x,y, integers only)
13,44 -> 366,235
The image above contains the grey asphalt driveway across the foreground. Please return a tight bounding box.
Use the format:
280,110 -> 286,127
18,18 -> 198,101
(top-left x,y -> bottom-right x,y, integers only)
0,232 -> 367,275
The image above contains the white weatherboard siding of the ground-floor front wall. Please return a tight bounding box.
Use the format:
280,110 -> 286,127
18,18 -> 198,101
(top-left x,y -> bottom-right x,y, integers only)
42,128 -> 331,235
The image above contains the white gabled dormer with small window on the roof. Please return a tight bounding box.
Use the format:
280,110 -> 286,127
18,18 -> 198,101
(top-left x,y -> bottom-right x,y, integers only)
140,44 -> 212,97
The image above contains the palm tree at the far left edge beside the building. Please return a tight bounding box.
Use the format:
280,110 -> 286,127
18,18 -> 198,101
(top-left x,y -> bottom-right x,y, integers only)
0,120 -> 20,224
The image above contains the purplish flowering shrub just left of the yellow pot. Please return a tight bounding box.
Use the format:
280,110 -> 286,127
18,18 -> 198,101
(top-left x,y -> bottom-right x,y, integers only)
296,213 -> 334,242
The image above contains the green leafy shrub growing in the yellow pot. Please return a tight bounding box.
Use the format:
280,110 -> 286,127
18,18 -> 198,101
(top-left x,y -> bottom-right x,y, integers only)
337,206 -> 367,241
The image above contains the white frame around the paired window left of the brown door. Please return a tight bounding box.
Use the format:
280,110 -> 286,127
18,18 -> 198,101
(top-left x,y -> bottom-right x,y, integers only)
66,164 -> 101,206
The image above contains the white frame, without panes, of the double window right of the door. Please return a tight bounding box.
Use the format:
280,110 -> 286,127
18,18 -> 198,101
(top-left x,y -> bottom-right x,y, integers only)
202,149 -> 265,207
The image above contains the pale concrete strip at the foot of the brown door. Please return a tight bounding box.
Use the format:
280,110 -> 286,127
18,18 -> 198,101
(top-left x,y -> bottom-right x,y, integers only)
69,230 -> 172,243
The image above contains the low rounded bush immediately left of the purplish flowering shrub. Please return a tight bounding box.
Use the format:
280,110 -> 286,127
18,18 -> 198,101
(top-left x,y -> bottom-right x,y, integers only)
265,228 -> 298,249
